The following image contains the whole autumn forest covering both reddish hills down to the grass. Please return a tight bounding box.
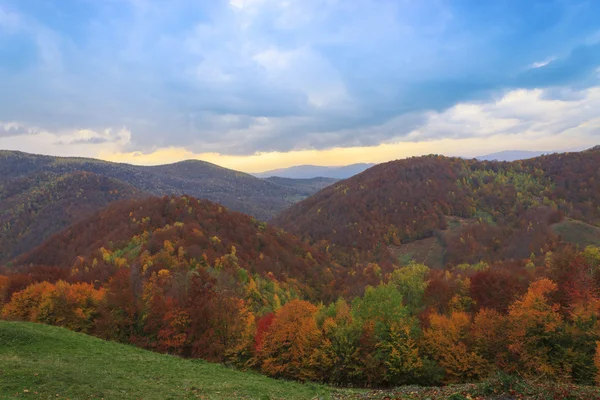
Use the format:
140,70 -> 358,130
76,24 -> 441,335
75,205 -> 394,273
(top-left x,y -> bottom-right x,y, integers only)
0,150 -> 600,387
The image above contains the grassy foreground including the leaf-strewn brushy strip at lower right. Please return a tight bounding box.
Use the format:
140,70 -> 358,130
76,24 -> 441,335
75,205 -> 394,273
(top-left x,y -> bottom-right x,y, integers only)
0,321 -> 600,400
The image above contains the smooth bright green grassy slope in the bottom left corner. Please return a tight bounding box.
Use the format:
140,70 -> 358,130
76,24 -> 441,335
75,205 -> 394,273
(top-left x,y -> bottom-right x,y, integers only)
0,321 -> 346,400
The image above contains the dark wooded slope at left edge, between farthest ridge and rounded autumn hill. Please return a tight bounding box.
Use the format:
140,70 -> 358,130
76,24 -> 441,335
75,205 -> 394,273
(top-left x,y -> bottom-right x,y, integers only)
0,172 -> 148,261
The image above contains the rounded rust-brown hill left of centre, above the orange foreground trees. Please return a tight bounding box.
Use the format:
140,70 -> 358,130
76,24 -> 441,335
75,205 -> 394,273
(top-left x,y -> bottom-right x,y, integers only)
13,196 -> 336,298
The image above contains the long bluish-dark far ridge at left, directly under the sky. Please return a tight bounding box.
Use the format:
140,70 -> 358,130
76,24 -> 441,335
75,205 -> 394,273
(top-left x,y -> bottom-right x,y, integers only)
0,151 -> 318,220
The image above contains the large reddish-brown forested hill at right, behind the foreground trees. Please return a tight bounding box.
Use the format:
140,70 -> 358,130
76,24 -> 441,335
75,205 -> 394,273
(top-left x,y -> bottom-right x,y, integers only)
273,148 -> 600,265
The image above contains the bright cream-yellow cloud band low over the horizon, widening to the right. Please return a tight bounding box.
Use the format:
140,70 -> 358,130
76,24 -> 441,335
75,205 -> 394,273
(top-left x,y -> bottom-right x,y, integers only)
94,87 -> 600,172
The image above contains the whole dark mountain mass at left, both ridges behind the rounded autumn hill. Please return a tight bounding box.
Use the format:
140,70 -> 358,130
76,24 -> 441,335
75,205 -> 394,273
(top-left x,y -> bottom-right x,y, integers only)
0,151 -> 333,261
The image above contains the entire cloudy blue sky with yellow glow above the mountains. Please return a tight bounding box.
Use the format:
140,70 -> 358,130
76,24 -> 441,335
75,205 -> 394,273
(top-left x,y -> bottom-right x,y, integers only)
0,0 -> 600,172
